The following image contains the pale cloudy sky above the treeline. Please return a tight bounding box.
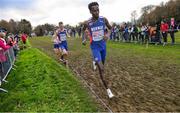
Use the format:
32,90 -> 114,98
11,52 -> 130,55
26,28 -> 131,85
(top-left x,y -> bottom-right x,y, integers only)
0,0 -> 169,26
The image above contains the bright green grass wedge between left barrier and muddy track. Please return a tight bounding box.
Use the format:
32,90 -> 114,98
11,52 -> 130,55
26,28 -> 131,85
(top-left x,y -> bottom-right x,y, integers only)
0,48 -> 97,112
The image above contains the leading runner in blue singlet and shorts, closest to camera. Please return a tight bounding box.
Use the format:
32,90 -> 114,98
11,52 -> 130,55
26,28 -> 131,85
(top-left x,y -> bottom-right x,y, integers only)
83,2 -> 114,98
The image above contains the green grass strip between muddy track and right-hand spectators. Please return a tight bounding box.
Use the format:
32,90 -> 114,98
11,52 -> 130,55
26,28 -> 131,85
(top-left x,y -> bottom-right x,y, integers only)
107,42 -> 180,64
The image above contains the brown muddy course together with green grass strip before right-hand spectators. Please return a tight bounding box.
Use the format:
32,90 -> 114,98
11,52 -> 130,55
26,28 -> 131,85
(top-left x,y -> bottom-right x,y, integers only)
30,33 -> 180,112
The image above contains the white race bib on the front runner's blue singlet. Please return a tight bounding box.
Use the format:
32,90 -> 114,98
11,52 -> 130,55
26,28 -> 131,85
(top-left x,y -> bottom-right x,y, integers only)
92,30 -> 104,41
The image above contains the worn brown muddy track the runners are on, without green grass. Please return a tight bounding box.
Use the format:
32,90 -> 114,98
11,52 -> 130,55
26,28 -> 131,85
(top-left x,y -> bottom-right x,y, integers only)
31,37 -> 180,112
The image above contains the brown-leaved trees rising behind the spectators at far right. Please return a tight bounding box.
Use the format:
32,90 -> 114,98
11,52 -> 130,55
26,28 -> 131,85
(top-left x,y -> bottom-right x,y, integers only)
138,0 -> 180,24
